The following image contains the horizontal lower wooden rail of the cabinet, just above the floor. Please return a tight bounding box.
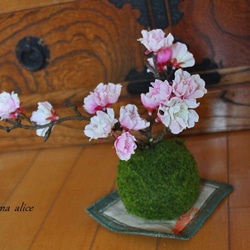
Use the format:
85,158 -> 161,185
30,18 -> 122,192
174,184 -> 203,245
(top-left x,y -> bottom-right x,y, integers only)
0,83 -> 250,151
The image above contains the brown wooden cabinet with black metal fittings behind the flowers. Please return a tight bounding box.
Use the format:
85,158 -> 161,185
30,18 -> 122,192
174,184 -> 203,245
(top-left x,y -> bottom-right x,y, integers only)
0,0 -> 250,150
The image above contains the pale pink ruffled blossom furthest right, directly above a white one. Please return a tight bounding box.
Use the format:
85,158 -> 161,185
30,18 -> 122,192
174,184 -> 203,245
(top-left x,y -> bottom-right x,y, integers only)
172,69 -> 207,99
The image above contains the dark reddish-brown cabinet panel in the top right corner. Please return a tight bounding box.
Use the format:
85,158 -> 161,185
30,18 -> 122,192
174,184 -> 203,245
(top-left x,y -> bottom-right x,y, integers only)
173,0 -> 250,68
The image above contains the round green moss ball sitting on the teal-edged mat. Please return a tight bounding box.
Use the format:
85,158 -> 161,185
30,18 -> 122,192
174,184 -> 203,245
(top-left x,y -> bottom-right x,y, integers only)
117,140 -> 200,220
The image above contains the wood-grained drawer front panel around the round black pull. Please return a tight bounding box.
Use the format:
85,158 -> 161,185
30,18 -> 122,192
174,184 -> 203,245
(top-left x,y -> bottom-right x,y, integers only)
0,0 -> 144,95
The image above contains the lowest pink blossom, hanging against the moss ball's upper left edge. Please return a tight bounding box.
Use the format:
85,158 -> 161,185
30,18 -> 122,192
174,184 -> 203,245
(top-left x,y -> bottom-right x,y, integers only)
114,132 -> 137,161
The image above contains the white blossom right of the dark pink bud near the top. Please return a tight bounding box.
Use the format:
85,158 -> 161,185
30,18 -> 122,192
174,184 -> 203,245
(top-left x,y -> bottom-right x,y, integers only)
170,42 -> 195,69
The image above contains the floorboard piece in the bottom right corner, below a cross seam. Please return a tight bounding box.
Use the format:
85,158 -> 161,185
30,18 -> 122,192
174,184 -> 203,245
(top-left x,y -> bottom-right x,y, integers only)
230,207 -> 250,250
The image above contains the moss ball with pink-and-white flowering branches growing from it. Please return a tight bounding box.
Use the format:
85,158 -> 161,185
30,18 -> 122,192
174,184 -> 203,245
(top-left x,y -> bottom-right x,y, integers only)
0,29 -> 207,219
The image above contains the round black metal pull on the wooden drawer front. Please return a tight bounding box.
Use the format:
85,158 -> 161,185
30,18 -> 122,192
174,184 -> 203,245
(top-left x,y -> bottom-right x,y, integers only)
16,36 -> 50,71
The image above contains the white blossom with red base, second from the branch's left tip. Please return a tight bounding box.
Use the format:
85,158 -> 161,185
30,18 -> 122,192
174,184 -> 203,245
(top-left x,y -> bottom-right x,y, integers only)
30,102 -> 59,137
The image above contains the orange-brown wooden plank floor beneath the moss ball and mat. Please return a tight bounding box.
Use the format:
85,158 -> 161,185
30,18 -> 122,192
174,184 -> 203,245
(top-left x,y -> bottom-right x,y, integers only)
0,131 -> 250,250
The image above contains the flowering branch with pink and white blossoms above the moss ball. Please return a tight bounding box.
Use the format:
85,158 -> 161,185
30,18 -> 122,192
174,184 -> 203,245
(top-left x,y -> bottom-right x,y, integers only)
0,29 -> 207,161
